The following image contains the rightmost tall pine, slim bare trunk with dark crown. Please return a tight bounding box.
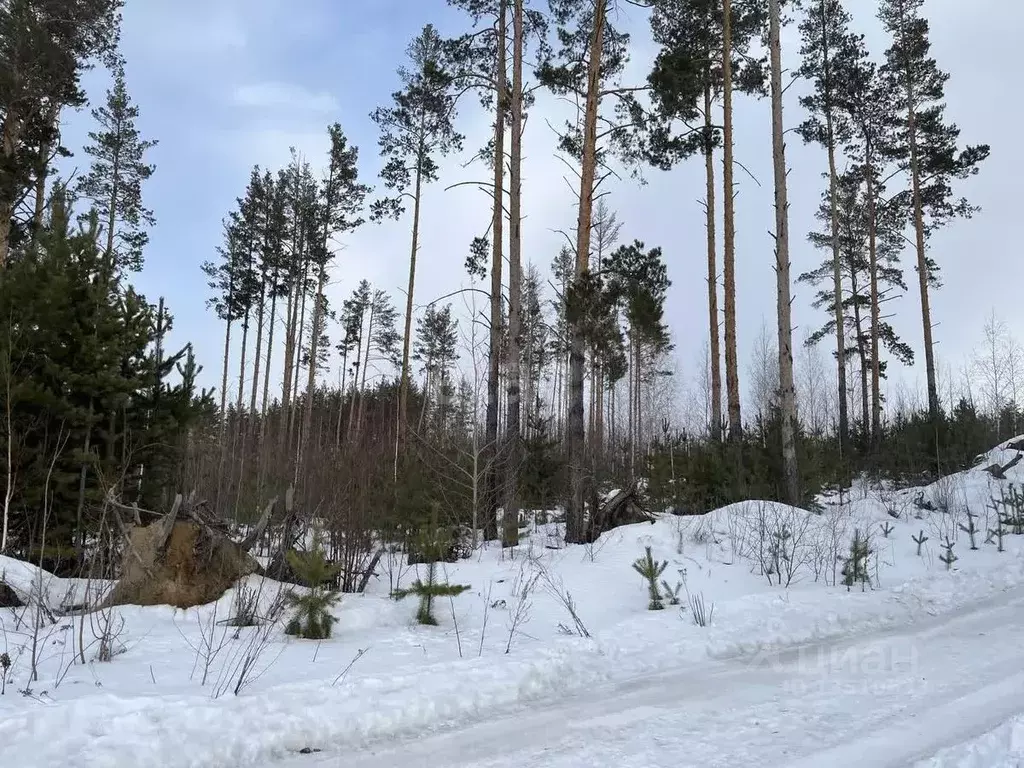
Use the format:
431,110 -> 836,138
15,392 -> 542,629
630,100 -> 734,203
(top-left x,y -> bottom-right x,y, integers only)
879,0 -> 989,436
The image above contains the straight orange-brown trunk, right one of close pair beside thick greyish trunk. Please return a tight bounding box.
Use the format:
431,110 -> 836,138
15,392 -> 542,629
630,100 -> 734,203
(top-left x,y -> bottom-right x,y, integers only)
722,0 -> 743,440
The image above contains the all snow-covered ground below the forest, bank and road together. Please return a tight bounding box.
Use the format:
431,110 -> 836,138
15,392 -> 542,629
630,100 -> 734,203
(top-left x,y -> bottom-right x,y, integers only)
0,447 -> 1024,768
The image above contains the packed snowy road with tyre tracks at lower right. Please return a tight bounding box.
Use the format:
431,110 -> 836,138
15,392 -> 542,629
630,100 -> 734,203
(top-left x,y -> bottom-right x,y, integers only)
279,590 -> 1024,768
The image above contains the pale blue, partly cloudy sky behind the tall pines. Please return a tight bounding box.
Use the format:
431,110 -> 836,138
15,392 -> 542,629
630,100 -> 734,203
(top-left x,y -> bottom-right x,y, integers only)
63,0 -> 1024,417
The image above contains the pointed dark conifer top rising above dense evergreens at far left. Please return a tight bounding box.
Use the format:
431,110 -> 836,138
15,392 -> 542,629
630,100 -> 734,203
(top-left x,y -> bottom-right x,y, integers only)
78,62 -> 157,280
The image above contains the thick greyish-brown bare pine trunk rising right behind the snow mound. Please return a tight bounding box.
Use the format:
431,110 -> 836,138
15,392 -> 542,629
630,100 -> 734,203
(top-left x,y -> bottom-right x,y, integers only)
768,0 -> 800,506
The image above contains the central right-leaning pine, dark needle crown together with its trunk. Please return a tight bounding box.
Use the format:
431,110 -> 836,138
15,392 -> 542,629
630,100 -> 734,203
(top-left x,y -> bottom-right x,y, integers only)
538,0 -> 644,543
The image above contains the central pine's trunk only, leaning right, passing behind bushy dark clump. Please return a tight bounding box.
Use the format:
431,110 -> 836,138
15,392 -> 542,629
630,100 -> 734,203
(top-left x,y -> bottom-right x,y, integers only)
565,0 -> 608,544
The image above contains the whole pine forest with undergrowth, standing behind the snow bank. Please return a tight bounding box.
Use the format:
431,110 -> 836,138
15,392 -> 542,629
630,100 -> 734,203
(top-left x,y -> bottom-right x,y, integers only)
0,0 -> 1007,569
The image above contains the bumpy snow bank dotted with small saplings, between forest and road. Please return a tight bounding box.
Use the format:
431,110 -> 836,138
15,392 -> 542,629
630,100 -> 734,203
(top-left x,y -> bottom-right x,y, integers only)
6,438 -> 1024,768
